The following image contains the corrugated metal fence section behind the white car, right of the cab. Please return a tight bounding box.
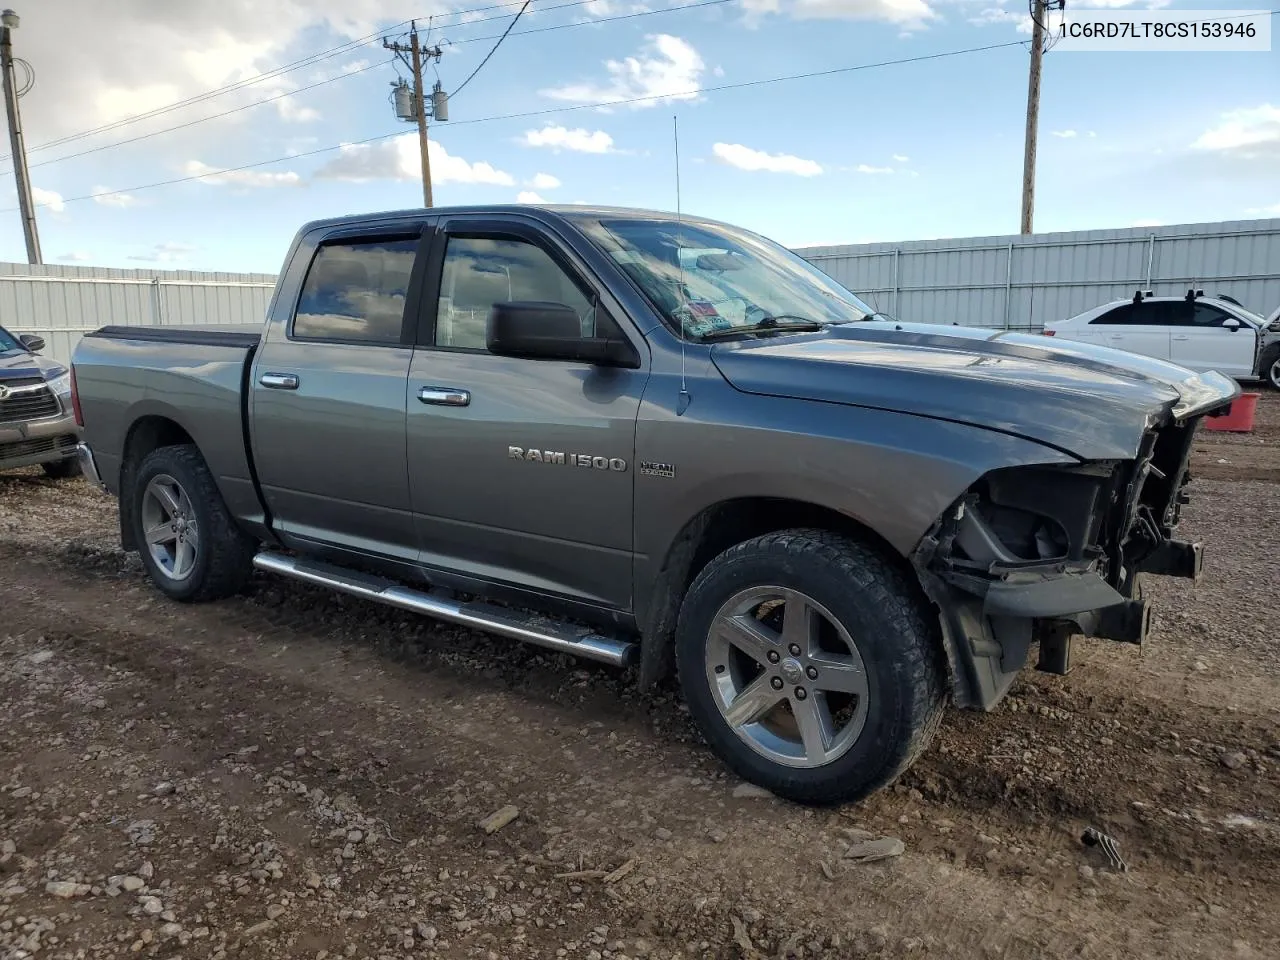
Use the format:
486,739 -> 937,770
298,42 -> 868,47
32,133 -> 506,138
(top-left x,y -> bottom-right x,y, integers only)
795,219 -> 1280,330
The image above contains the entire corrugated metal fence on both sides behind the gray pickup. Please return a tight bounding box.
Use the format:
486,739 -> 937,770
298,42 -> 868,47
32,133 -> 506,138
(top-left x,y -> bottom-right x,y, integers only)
10,219 -> 1280,361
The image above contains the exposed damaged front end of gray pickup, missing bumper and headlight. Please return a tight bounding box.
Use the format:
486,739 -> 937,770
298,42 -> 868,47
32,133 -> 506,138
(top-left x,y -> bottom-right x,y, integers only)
913,415 -> 1201,709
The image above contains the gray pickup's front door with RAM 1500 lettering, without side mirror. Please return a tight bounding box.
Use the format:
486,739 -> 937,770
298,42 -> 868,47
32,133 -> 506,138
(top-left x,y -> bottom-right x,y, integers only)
407,218 -> 648,609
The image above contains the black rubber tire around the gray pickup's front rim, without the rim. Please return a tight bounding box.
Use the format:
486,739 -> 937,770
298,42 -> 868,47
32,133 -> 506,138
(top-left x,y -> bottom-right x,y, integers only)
676,529 -> 946,804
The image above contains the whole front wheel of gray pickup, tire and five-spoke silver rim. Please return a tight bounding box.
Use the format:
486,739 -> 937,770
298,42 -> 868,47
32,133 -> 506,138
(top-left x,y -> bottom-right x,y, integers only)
676,530 -> 945,804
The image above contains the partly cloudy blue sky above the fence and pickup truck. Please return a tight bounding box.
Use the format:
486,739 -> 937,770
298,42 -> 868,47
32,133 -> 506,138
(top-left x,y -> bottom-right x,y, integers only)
0,0 -> 1280,273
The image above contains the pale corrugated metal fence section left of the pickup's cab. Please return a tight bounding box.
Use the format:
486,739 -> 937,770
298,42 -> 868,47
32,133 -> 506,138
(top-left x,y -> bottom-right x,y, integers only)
0,264 -> 275,362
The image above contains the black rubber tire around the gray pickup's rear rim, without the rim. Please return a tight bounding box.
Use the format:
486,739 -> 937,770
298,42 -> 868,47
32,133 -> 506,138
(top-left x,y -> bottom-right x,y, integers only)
129,444 -> 257,602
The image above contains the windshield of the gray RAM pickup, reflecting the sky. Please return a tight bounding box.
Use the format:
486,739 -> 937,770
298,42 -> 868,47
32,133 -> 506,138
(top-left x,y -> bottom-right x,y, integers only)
580,218 -> 874,339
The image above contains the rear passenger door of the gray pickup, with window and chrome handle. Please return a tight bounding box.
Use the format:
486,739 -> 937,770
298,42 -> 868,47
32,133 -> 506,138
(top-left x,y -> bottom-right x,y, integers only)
251,220 -> 430,562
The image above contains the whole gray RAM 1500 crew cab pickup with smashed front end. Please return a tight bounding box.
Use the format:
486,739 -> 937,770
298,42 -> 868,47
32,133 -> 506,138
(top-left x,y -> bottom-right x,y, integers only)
72,206 -> 1240,803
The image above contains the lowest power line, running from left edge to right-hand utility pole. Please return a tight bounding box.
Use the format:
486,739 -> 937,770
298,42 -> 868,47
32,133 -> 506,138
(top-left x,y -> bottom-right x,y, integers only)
0,40 -> 1028,214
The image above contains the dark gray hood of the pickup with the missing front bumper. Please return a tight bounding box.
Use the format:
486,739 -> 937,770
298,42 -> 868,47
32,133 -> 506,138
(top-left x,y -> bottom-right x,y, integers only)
712,320 -> 1240,460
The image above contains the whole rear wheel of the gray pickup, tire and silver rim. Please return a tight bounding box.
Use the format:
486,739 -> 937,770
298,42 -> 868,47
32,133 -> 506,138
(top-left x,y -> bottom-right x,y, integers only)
132,444 -> 255,600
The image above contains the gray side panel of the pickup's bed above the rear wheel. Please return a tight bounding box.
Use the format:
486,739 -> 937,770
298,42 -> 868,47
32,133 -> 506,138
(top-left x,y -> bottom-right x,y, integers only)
73,325 -> 264,535
